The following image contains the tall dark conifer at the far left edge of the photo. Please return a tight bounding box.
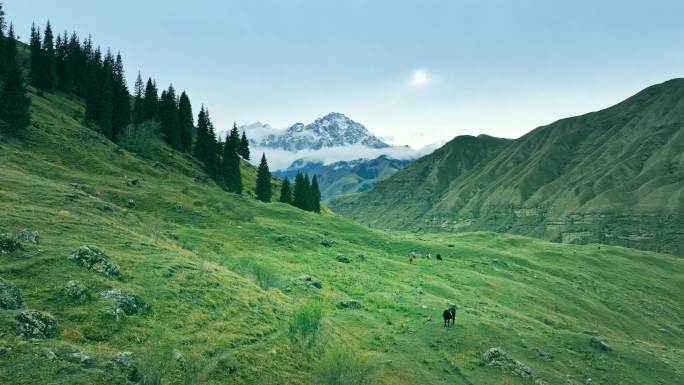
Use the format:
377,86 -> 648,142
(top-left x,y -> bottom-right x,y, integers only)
0,26 -> 31,133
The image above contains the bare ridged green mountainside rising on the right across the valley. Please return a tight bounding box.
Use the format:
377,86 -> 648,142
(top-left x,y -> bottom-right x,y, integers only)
330,79 -> 684,255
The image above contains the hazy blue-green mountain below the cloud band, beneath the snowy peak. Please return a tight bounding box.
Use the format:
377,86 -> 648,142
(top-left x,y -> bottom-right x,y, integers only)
273,155 -> 413,201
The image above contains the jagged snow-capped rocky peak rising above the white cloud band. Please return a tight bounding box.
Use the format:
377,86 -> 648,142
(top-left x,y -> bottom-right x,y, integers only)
240,112 -> 391,152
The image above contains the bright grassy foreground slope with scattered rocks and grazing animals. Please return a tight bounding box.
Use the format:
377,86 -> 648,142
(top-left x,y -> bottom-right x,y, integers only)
0,85 -> 684,385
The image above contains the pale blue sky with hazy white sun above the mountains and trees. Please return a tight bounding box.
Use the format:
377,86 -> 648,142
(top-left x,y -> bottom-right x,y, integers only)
5,0 -> 684,147
